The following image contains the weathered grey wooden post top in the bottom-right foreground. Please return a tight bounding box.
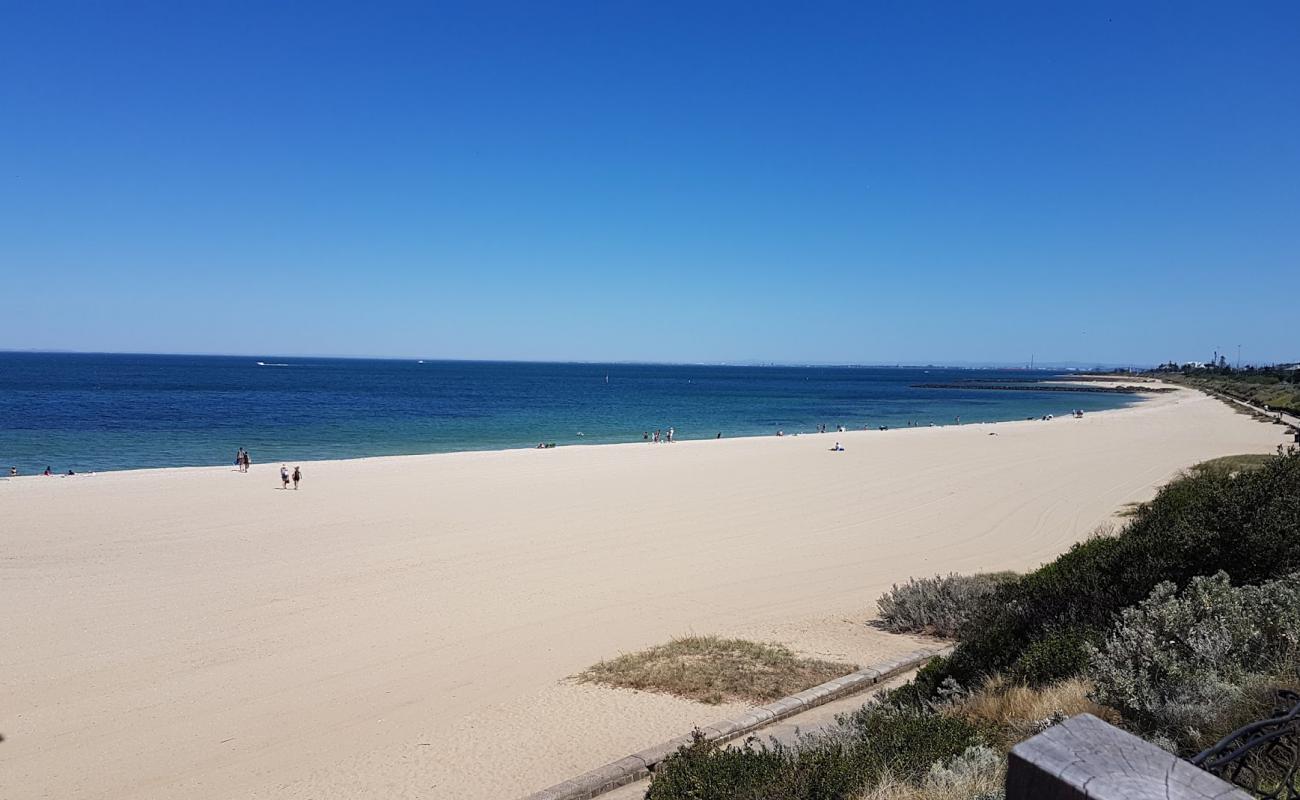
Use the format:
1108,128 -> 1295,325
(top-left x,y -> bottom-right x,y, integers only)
1006,714 -> 1251,800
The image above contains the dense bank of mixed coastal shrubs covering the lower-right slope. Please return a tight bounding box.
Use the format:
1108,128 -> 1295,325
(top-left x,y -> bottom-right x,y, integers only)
647,453 -> 1300,800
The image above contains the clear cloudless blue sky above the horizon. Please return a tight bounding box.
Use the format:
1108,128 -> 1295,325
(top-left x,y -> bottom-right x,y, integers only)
0,0 -> 1300,363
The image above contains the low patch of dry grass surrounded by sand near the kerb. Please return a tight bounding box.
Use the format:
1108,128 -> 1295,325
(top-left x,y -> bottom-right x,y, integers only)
577,636 -> 858,705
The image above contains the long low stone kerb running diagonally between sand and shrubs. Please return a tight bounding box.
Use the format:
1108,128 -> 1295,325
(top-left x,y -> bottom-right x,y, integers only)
521,648 -> 952,800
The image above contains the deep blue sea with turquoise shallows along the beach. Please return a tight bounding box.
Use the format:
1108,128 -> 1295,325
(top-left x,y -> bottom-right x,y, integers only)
0,353 -> 1135,475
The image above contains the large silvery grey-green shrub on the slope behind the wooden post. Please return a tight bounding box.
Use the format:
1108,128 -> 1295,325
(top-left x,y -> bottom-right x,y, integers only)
1089,572 -> 1300,749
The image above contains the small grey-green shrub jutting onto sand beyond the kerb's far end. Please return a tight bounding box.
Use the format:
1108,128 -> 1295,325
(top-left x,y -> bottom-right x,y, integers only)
876,572 -> 1015,639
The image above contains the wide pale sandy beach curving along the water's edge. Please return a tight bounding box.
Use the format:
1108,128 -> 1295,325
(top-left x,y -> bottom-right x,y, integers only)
0,392 -> 1281,800
